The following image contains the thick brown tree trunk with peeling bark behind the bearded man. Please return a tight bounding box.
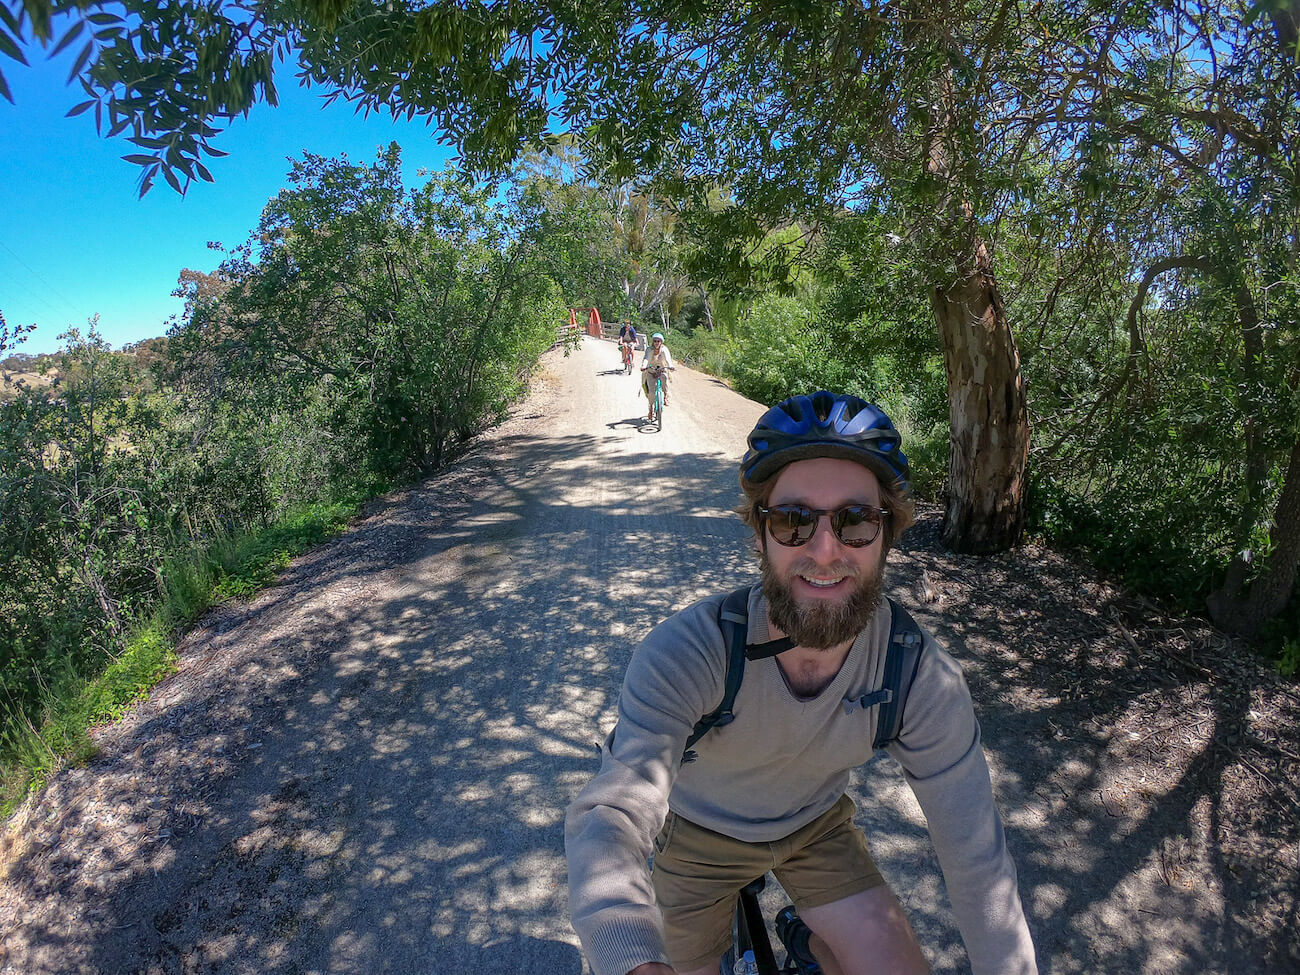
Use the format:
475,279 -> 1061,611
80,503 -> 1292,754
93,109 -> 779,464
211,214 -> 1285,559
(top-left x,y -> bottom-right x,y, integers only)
930,243 -> 1030,555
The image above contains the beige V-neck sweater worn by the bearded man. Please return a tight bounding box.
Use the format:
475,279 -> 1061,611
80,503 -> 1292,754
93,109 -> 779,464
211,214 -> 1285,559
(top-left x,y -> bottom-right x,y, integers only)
564,586 -> 1037,975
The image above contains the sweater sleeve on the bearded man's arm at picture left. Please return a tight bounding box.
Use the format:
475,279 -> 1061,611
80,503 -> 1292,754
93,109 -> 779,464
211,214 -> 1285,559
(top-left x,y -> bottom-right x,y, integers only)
564,601 -> 725,975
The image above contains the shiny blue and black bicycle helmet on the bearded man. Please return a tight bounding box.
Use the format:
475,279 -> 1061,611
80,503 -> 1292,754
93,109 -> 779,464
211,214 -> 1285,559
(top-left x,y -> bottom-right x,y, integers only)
740,390 -> 910,494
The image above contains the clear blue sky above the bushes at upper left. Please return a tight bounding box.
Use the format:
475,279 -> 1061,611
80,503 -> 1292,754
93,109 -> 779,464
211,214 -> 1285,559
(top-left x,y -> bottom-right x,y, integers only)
0,46 -> 452,354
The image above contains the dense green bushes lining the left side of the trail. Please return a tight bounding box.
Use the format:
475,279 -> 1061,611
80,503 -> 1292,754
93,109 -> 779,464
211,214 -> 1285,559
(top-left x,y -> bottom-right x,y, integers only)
0,148 -> 572,803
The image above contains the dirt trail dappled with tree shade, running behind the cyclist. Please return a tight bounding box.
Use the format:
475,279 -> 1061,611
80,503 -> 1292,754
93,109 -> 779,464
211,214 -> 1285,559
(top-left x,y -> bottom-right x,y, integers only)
0,339 -> 1300,975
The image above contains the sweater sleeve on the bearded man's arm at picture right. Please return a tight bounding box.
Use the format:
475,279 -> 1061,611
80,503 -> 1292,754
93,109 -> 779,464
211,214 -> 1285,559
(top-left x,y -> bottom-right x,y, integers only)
889,644 -> 1037,975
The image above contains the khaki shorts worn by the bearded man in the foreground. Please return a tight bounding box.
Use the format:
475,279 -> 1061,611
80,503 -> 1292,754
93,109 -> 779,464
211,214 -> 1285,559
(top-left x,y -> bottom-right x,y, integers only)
650,796 -> 885,971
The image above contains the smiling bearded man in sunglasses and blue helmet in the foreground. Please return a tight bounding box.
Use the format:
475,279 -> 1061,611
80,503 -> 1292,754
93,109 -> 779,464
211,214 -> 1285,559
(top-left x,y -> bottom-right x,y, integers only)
566,391 -> 1037,975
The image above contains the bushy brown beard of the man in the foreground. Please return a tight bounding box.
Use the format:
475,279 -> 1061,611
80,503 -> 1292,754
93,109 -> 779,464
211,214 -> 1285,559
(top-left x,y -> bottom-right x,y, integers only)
759,551 -> 884,650
